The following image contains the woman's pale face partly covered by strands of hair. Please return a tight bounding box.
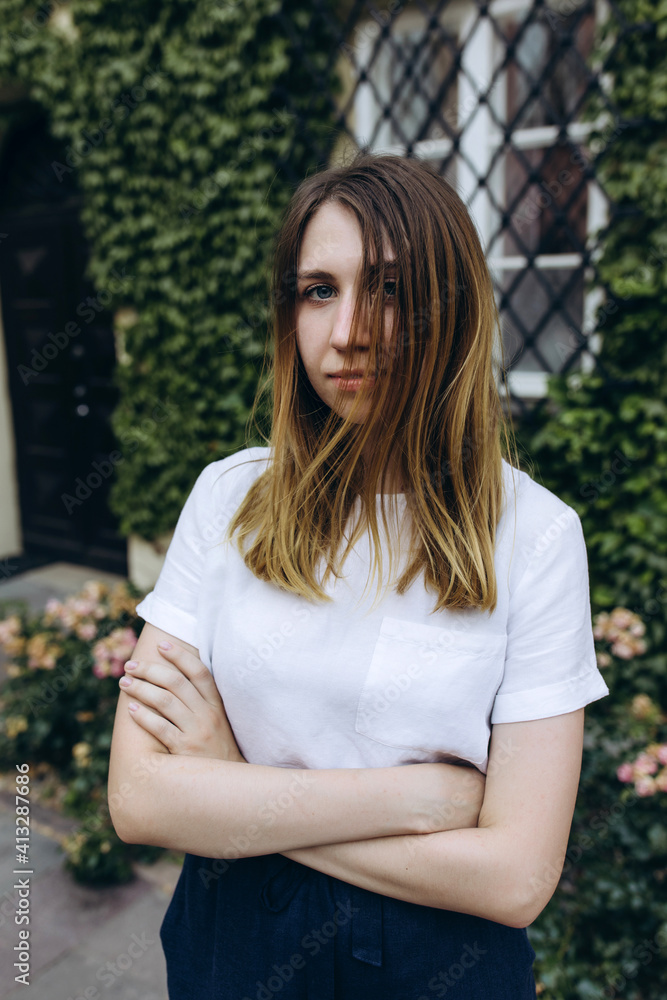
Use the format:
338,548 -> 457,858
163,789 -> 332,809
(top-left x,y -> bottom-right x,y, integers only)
296,202 -> 395,423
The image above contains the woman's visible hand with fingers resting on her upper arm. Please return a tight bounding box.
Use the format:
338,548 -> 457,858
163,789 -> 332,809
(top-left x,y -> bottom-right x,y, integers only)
118,645 -> 247,763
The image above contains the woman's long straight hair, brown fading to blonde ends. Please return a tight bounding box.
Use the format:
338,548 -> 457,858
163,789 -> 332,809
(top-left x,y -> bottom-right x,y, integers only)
226,151 -> 511,612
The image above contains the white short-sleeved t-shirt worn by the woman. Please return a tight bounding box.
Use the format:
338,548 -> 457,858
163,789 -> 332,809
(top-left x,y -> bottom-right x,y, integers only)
137,448 -> 609,773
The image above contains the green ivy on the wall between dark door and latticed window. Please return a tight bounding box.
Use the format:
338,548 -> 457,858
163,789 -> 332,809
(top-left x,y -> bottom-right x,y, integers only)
0,0 -> 338,539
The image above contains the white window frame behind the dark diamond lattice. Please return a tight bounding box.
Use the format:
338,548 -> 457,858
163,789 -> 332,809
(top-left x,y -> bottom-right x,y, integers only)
344,0 -> 609,400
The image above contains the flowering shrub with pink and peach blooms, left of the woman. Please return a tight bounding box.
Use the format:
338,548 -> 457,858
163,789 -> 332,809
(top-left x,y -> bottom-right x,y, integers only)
0,581 -> 156,882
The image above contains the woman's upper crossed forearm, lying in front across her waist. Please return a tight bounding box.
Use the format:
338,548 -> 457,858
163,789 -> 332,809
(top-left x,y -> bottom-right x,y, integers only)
109,753 -> 429,858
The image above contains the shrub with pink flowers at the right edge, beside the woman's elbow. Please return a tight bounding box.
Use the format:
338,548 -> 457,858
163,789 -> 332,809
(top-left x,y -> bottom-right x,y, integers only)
529,620 -> 667,1000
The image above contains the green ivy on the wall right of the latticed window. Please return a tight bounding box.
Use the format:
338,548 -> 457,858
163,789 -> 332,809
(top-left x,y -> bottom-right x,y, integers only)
522,0 -> 667,705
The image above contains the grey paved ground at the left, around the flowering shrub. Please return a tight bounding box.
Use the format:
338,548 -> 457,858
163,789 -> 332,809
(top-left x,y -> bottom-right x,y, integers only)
0,563 -> 180,1000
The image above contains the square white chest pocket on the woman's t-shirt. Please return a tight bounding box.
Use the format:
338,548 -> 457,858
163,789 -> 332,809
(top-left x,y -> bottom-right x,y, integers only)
355,617 -> 507,763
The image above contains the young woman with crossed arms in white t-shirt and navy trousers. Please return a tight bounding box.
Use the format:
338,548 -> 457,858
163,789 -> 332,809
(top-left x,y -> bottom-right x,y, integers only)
109,153 -> 608,1000
